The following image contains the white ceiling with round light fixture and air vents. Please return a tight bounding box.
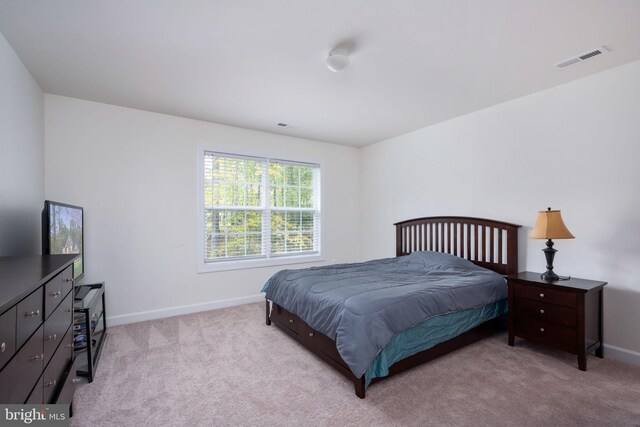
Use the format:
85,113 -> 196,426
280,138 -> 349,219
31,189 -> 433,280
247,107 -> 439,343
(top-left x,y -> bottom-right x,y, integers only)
0,0 -> 640,146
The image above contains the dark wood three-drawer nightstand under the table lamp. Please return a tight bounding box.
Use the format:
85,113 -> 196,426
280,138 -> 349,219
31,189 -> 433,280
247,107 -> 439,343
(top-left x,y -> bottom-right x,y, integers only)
507,271 -> 607,371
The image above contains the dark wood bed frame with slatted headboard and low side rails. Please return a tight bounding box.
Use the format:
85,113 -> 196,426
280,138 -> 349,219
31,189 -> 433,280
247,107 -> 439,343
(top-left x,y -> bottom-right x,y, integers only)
266,216 -> 520,399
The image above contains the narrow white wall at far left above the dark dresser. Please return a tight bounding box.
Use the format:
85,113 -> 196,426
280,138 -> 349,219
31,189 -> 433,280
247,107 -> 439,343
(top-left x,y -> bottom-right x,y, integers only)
0,34 -> 44,256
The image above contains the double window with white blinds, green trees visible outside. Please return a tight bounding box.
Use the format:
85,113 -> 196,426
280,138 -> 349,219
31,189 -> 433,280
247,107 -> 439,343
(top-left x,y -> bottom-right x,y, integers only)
200,151 -> 320,265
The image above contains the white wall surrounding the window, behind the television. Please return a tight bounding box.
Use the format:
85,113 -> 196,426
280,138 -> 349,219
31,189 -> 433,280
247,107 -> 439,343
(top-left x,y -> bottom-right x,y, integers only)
45,95 -> 359,322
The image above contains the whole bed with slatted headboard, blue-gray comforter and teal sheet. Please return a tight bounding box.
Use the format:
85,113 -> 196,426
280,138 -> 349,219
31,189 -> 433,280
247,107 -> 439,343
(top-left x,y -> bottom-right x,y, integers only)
263,217 -> 520,399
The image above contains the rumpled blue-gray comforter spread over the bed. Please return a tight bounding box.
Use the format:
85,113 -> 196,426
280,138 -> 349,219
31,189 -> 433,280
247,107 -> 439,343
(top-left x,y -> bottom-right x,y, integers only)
262,251 -> 507,377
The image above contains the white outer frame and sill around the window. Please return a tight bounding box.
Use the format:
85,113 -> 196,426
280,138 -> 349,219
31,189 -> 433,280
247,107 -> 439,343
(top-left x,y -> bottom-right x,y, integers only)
197,145 -> 325,273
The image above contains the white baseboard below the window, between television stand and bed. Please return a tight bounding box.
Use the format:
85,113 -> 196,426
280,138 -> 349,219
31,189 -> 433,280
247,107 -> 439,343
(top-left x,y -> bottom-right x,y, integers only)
107,294 -> 264,326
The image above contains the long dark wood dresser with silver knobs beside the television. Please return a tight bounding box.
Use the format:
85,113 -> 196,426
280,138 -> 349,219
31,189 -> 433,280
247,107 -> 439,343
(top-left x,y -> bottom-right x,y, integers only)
0,255 -> 77,404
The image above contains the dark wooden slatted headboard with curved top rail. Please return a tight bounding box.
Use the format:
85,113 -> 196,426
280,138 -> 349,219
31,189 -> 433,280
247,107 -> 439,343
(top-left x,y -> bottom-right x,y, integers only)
394,216 -> 521,274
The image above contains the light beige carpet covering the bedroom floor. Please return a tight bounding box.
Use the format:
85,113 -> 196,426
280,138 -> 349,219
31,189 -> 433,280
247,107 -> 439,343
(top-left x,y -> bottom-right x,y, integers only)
72,304 -> 640,426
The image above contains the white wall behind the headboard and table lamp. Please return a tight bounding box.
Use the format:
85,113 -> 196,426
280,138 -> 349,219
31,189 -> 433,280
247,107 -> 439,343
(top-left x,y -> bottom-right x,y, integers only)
361,62 -> 640,356
